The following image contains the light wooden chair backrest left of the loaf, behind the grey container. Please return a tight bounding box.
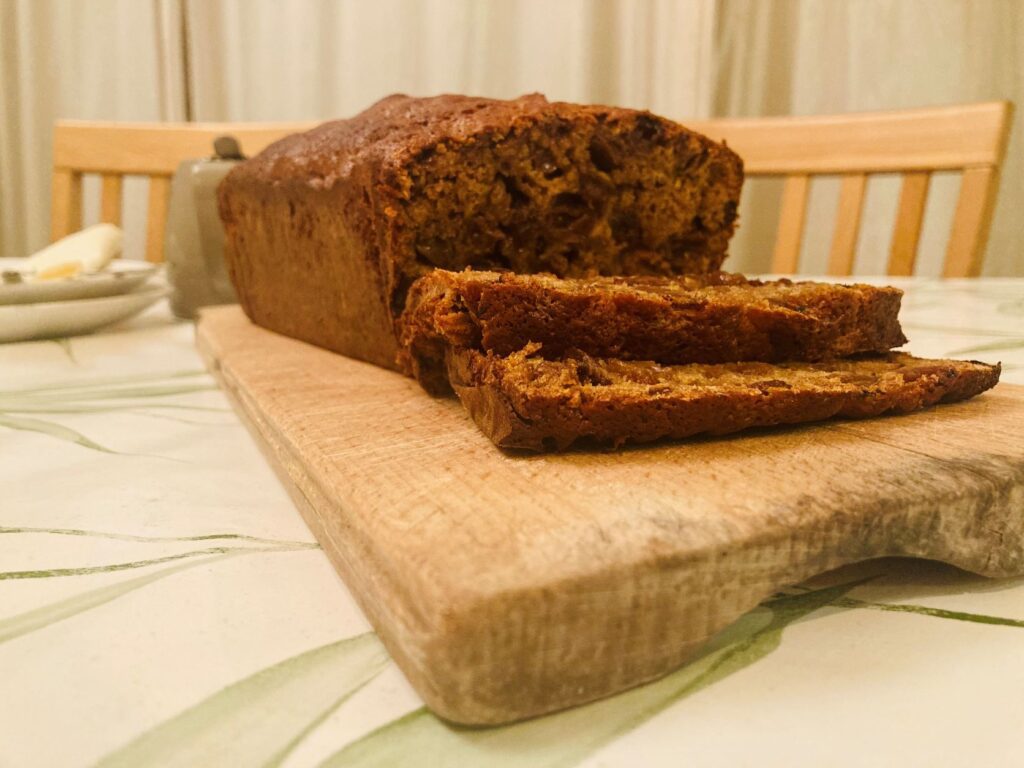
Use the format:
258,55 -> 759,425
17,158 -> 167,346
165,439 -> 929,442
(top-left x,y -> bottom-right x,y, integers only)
50,120 -> 315,262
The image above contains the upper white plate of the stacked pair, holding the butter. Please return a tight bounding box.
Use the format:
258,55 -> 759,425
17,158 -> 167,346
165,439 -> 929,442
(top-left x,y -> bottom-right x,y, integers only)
0,258 -> 158,305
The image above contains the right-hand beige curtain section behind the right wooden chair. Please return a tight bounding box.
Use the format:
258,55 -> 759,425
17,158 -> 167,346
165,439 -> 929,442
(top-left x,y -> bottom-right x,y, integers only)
714,0 -> 1024,275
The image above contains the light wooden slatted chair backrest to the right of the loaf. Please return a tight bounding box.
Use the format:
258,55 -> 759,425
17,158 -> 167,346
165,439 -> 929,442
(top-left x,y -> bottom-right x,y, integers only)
686,101 -> 1013,278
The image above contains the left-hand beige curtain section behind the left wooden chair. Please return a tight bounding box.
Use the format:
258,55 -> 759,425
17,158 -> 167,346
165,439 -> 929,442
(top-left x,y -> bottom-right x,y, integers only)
0,0 -> 185,256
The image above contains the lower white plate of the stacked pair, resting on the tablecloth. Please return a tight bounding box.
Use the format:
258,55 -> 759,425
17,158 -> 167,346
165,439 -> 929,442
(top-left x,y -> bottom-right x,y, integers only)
0,287 -> 170,342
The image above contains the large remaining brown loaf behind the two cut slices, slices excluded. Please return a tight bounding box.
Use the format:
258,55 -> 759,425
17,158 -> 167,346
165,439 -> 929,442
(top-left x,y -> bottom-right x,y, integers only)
219,95 -> 743,368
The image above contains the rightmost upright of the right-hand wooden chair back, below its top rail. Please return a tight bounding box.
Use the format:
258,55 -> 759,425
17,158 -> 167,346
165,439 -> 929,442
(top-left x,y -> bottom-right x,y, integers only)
942,166 -> 998,278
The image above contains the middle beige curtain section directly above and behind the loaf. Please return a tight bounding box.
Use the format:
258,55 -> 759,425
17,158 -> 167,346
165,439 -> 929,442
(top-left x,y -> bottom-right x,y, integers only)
186,0 -> 715,120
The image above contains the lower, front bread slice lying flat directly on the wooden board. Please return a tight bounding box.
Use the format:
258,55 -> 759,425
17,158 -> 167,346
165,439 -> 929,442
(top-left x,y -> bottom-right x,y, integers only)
447,344 -> 999,451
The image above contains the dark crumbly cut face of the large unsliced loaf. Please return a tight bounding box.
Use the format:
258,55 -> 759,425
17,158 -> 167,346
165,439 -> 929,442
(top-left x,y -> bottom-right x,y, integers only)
390,100 -> 742,311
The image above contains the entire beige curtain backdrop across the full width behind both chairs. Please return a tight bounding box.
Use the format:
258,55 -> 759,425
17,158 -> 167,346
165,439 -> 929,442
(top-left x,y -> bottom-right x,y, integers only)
0,0 -> 1024,274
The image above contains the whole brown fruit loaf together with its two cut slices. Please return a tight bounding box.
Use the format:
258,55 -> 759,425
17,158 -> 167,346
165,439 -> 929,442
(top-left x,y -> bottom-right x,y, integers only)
219,95 -> 999,451
